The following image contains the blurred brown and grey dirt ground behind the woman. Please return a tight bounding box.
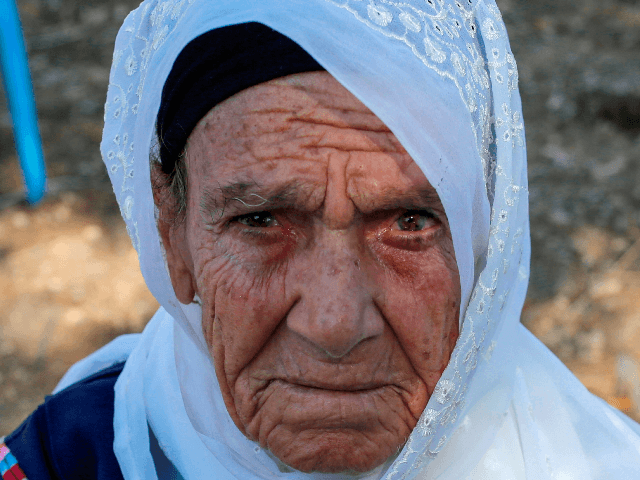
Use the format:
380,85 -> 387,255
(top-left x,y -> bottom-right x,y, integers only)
0,0 -> 640,435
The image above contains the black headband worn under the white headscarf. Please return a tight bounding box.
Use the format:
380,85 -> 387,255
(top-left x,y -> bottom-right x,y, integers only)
156,22 -> 324,174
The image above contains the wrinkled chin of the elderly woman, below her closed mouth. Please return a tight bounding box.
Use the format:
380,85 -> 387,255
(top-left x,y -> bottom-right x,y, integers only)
236,380 -> 426,473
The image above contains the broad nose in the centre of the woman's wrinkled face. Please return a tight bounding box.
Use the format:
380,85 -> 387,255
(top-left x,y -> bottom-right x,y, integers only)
287,242 -> 384,359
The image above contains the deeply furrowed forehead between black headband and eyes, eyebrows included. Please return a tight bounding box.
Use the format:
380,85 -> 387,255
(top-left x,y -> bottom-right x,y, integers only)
186,72 -> 441,208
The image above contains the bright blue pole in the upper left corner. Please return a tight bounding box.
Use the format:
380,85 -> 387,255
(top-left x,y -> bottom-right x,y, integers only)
0,0 -> 46,204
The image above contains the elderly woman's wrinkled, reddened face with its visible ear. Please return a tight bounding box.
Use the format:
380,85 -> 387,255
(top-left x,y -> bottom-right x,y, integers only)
156,72 -> 460,472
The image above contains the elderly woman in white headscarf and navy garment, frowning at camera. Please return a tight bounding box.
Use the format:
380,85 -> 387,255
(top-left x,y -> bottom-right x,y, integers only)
0,0 -> 640,480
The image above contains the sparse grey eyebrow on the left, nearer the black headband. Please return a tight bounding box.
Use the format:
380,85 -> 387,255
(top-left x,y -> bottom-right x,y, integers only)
200,179 -> 308,220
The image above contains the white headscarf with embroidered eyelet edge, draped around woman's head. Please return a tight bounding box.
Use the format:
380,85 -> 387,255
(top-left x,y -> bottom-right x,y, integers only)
53,0 -> 640,480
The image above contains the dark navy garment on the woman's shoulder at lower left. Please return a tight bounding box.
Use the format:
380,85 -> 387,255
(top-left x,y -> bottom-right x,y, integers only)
4,363 -> 124,480
